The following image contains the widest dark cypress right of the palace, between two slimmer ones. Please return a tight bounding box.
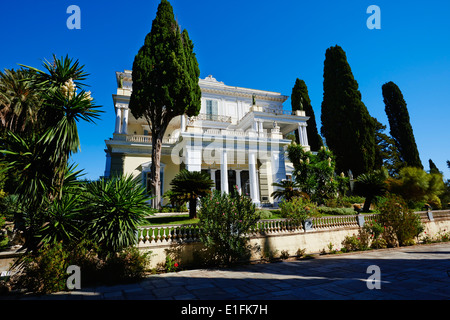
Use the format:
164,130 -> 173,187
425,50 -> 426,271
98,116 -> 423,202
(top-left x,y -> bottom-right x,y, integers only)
321,46 -> 375,176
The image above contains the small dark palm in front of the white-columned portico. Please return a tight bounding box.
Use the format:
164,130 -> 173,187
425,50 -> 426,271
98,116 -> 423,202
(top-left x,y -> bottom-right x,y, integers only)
170,170 -> 214,219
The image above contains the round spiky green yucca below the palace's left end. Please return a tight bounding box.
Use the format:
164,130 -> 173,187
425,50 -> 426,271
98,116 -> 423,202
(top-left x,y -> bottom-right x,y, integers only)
83,176 -> 150,255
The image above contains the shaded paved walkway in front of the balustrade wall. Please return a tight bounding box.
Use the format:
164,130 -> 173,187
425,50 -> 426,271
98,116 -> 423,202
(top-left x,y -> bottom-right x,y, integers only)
0,242 -> 450,300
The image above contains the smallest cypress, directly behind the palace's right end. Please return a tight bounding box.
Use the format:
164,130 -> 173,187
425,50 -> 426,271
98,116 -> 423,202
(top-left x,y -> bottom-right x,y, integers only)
291,78 -> 323,151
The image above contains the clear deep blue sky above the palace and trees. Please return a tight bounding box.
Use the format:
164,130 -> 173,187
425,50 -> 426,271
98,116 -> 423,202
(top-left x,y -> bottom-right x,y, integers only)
0,0 -> 450,179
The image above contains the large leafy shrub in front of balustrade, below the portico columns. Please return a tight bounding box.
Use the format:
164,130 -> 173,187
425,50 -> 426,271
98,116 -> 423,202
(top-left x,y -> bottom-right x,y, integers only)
199,189 -> 259,265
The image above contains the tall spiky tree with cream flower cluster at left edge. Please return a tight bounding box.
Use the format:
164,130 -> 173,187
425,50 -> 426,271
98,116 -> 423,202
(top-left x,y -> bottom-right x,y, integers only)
0,56 -> 100,250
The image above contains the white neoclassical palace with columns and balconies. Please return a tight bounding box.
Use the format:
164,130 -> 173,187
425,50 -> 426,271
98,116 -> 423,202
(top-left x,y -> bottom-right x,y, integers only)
104,70 -> 309,206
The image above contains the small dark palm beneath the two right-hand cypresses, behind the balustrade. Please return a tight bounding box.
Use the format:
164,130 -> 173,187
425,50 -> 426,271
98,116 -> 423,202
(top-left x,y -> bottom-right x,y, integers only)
354,168 -> 389,212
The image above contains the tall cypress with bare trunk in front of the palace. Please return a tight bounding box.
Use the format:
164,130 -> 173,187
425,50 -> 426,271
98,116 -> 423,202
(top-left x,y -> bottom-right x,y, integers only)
129,0 -> 201,208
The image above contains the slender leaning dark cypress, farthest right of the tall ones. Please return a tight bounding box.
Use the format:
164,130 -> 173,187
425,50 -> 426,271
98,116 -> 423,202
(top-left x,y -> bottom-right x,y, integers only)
382,81 -> 423,169
